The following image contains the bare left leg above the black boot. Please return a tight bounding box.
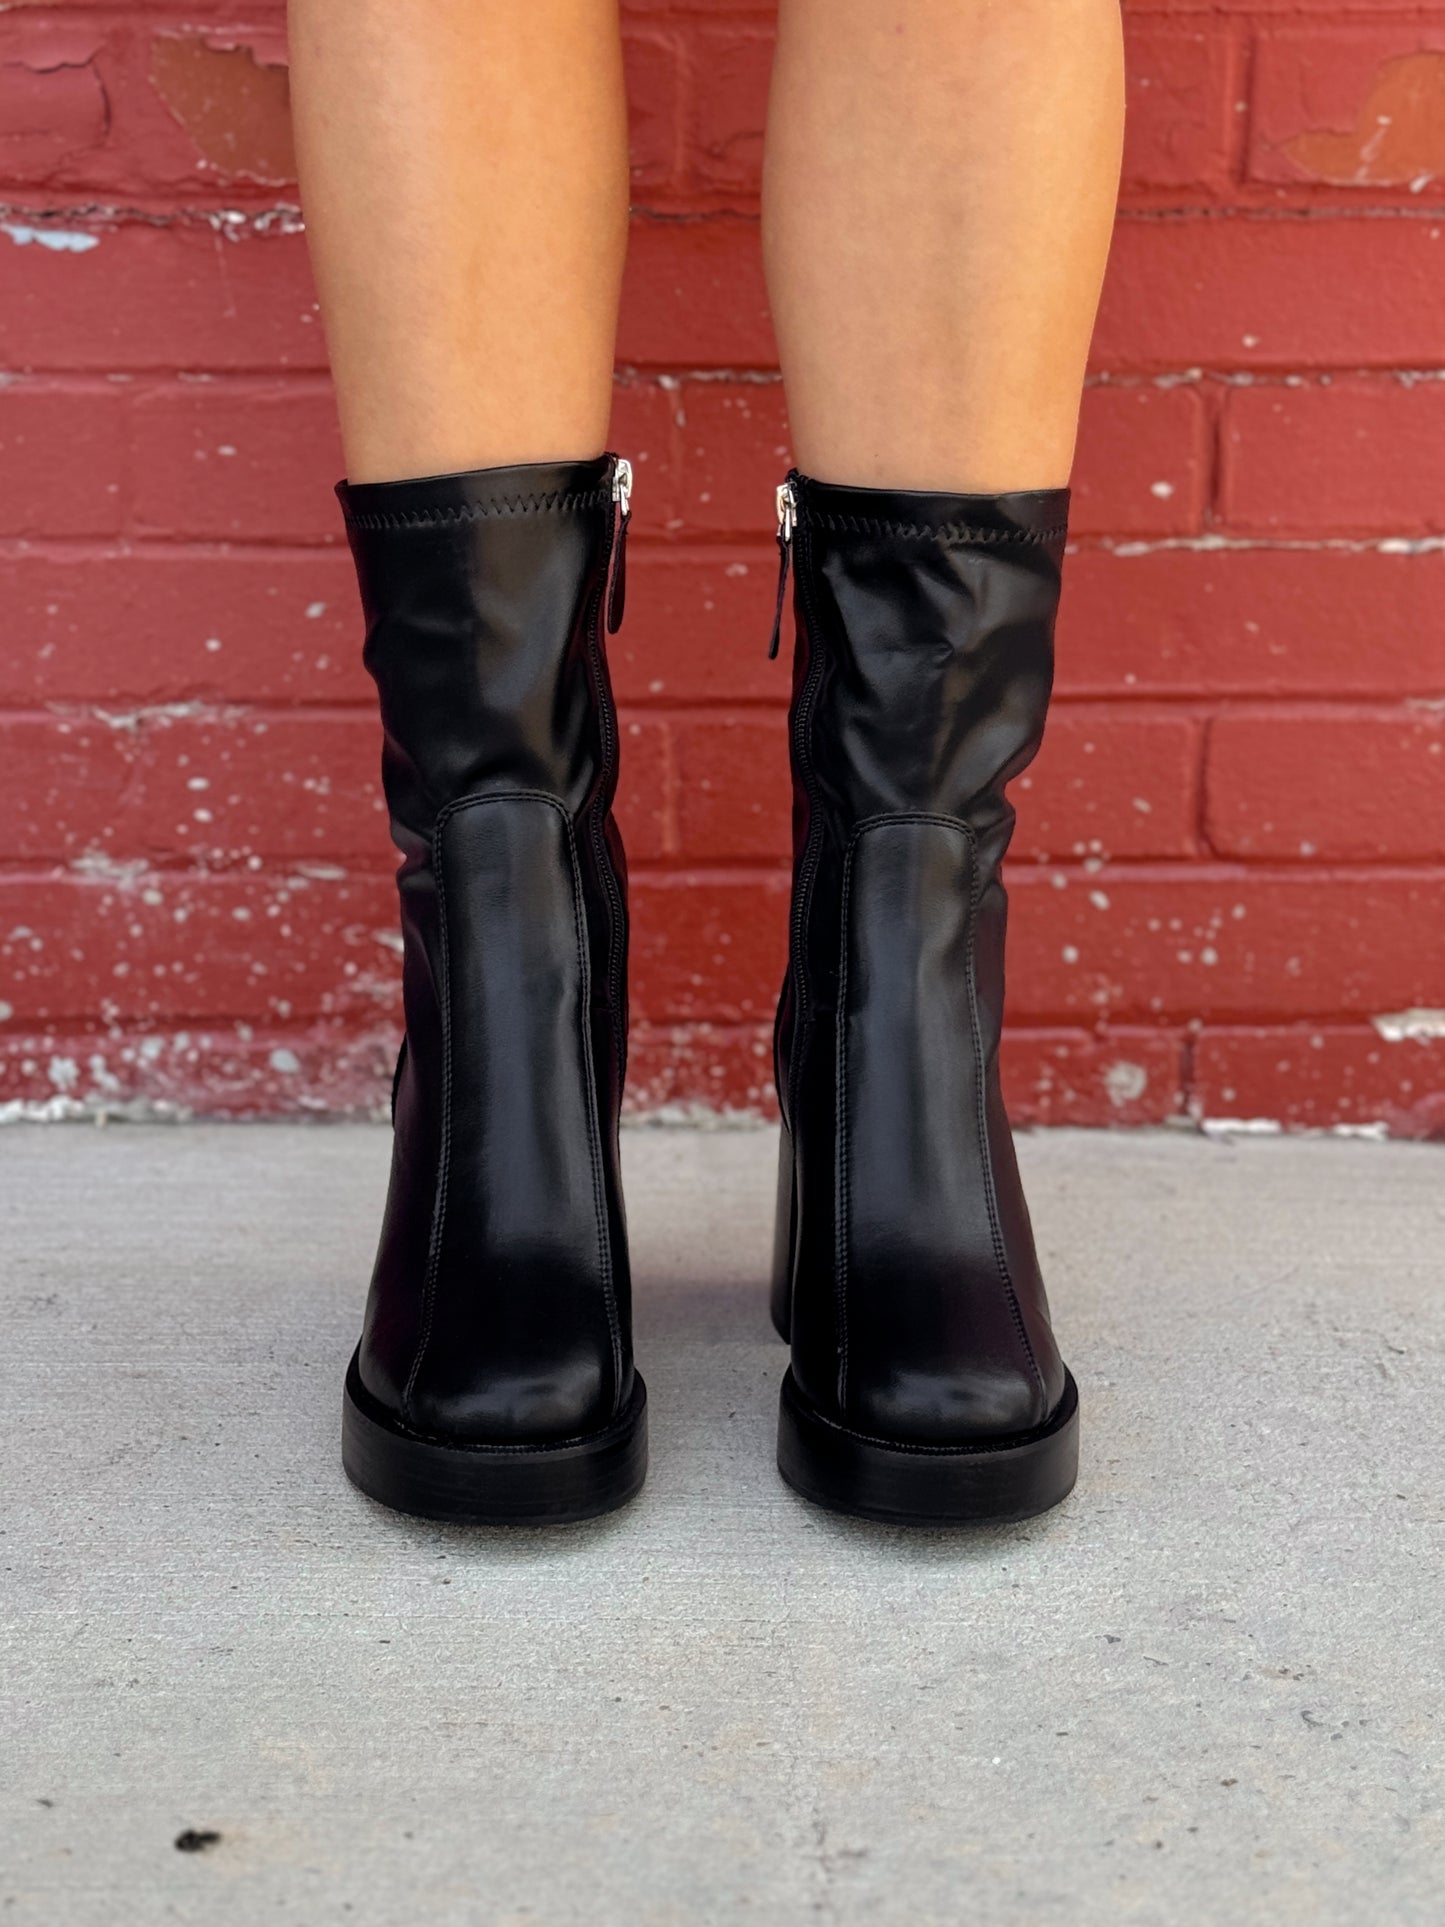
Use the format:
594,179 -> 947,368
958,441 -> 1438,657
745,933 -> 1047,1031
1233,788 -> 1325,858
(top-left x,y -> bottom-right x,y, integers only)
289,0 -> 628,482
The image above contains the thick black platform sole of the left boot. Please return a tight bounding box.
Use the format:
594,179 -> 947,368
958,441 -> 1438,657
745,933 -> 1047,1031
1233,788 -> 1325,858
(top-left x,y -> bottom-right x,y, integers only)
341,1357 -> 647,1526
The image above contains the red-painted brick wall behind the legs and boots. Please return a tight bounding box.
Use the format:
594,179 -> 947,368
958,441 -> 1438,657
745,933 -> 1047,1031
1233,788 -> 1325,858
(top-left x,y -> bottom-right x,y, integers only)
0,0 -> 1445,1131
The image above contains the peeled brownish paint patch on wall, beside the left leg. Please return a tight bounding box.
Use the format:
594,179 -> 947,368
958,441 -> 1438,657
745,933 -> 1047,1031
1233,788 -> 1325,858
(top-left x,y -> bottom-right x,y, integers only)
150,33 -> 297,183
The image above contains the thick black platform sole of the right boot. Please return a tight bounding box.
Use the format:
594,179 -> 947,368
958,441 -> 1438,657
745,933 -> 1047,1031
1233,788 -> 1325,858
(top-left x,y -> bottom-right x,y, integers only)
778,1372 -> 1079,1526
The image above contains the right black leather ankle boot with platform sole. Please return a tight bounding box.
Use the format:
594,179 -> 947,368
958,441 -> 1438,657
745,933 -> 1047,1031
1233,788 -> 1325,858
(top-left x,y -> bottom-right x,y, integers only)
773,472 -> 1079,1524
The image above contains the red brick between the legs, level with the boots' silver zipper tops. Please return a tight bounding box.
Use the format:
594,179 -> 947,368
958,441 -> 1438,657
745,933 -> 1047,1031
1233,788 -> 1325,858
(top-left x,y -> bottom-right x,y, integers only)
678,382 -> 792,536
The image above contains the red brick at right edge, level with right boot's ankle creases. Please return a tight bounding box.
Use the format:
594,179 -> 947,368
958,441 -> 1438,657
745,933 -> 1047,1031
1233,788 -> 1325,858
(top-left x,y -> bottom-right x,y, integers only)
1206,711 -> 1445,859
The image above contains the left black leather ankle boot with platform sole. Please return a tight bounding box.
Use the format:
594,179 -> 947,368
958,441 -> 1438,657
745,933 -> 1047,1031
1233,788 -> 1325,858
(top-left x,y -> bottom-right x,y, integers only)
337,455 -> 647,1524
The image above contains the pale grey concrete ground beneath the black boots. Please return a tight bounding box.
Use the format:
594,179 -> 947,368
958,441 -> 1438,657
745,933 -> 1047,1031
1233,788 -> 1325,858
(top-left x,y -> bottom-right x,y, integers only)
0,1125 -> 1445,1927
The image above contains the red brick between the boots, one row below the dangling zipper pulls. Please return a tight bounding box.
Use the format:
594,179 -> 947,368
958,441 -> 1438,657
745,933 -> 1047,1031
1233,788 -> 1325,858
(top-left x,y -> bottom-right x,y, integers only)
674,711 -> 792,863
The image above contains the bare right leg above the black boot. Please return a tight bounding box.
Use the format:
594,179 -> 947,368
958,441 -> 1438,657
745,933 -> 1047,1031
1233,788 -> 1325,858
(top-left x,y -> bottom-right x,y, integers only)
763,0 -> 1123,493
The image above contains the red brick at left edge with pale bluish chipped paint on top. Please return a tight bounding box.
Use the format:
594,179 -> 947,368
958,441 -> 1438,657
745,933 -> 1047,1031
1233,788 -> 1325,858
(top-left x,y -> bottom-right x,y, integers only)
0,214 -> 326,372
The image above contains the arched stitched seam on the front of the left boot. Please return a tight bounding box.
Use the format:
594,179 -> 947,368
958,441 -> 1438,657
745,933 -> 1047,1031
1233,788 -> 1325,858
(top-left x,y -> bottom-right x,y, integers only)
401,790 -> 622,1424
